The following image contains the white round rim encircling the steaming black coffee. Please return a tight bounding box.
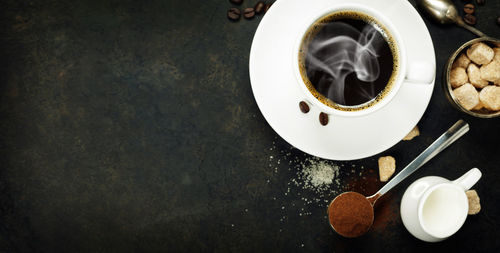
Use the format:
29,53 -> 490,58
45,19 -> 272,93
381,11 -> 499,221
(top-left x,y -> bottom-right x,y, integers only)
292,3 -> 407,117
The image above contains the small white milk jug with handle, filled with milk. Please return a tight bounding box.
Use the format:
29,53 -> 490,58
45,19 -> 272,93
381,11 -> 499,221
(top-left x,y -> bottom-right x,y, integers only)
401,168 -> 481,242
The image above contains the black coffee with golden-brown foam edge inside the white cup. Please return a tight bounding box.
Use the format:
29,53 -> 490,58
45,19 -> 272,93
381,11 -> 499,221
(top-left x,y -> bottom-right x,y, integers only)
298,10 -> 399,111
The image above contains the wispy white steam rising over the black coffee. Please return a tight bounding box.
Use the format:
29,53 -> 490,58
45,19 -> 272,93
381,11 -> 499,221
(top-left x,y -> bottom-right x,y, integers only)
306,21 -> 392,105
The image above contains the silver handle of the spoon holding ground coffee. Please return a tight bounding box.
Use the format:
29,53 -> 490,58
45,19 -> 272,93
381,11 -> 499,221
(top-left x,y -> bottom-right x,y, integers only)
372,120 -> 469,200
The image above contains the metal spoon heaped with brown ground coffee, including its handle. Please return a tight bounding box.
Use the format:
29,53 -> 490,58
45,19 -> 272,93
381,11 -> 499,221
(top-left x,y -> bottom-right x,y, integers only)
328,120 -> 469,238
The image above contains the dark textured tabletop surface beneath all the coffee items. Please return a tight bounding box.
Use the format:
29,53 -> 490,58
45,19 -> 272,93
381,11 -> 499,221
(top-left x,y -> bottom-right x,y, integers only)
0,0 -> 500,252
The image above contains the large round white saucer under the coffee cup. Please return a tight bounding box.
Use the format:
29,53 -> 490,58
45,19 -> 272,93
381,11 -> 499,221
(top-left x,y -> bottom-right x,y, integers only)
250,0 -> 436,160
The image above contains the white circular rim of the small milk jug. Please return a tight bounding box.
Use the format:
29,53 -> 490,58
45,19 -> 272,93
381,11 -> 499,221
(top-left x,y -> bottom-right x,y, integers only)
417,182 -> 469,239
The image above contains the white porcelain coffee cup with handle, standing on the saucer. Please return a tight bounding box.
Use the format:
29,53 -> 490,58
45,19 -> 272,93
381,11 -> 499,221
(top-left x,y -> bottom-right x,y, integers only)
292,3 -> 435,117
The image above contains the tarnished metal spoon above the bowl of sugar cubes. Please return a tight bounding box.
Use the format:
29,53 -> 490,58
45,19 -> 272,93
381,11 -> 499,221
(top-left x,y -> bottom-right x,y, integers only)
417,0 -> 486,37
